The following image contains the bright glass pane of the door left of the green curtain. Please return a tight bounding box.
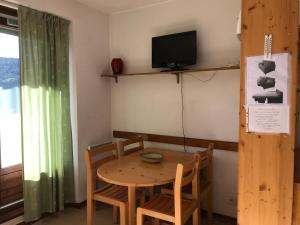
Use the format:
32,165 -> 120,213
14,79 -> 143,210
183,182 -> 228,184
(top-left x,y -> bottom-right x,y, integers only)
0,33 -> 22,169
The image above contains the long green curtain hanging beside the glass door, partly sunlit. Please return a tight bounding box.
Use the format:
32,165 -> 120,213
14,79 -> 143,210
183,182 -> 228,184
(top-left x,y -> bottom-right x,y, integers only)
18,7 -> 74,222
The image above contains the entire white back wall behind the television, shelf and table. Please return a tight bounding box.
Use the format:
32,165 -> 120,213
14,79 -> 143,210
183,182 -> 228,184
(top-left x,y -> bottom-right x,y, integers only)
110,0 -> 241,216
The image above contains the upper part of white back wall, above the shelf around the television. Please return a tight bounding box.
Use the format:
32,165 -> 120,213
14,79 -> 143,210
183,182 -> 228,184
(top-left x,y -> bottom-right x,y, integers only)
110,0 -> 241,72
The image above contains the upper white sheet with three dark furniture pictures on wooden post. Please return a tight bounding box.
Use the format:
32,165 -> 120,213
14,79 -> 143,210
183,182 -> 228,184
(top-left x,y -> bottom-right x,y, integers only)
246,53 -> 289,105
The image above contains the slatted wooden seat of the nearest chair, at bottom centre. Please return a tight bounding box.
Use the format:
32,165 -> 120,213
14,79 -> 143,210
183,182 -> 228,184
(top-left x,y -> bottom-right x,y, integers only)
141,194 -> 197,223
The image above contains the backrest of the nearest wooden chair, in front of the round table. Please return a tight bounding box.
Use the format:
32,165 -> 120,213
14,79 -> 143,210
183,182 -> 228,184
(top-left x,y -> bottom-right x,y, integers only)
174,153 -> 200,221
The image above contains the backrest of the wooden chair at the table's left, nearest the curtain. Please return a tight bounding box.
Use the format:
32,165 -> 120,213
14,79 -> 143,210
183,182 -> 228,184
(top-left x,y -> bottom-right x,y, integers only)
84,143 -> 118,192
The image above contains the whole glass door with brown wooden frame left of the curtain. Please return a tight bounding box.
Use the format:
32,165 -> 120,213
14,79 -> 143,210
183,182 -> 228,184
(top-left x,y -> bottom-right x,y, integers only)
0,12 -> 23,223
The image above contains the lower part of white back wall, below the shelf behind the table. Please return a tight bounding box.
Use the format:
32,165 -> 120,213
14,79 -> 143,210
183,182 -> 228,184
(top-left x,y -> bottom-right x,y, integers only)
111,70 -> 239,217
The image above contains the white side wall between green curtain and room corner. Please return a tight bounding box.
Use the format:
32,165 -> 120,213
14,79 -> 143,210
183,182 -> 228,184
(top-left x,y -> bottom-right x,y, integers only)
10,0 -> 111,202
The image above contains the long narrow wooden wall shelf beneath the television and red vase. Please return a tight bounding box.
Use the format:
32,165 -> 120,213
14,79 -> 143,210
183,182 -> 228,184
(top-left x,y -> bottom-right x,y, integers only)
101,66 -> 240,83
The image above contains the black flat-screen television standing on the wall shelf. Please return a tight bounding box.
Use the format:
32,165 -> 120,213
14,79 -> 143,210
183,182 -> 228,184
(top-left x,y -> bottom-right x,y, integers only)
152,31 -> 197,70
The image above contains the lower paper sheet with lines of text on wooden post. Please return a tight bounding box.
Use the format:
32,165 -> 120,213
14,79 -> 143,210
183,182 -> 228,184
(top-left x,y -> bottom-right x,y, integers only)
248,105 -> 290,133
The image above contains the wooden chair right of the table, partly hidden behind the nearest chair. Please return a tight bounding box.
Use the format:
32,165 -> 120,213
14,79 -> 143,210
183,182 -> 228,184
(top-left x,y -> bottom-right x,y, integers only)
161,143 -> 214,225
